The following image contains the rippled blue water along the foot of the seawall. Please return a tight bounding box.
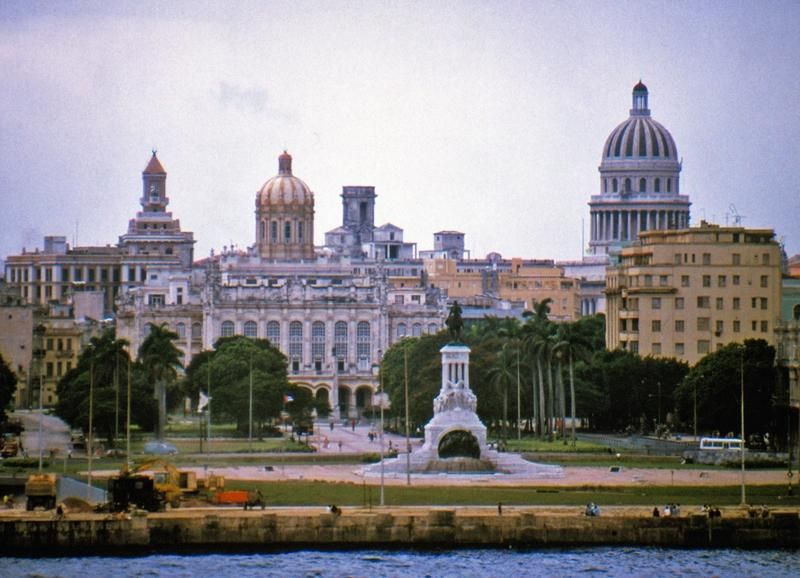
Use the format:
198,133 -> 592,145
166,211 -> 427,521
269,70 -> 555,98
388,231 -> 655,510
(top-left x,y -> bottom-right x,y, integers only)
0,548 -> 800,578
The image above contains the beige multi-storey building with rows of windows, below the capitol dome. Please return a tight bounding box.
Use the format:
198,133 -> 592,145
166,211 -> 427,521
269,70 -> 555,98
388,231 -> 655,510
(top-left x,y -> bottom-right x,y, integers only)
606,222 -> 781,364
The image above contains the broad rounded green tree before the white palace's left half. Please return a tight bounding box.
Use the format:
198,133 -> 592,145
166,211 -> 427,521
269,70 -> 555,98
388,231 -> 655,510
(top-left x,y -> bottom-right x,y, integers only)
183,335 -> 290,435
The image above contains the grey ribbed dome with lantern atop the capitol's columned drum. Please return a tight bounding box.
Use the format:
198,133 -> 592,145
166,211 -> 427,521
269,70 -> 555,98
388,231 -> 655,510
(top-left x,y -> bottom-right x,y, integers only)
603,81 -> 678,162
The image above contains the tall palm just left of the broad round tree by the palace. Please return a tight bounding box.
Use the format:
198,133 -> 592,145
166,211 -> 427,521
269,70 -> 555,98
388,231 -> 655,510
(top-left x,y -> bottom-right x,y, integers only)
139,323 -> 183,439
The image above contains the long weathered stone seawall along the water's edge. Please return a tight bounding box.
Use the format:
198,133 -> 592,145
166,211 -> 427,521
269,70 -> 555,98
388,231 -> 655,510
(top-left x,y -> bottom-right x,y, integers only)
0,508 -> 800,556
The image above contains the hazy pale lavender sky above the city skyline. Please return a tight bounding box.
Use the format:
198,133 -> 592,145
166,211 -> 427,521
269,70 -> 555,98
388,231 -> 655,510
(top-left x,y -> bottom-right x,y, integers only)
0,0 -> 800,259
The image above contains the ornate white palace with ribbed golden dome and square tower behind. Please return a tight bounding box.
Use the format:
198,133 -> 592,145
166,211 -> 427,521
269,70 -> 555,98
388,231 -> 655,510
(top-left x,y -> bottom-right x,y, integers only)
117,152 -> 446,419
